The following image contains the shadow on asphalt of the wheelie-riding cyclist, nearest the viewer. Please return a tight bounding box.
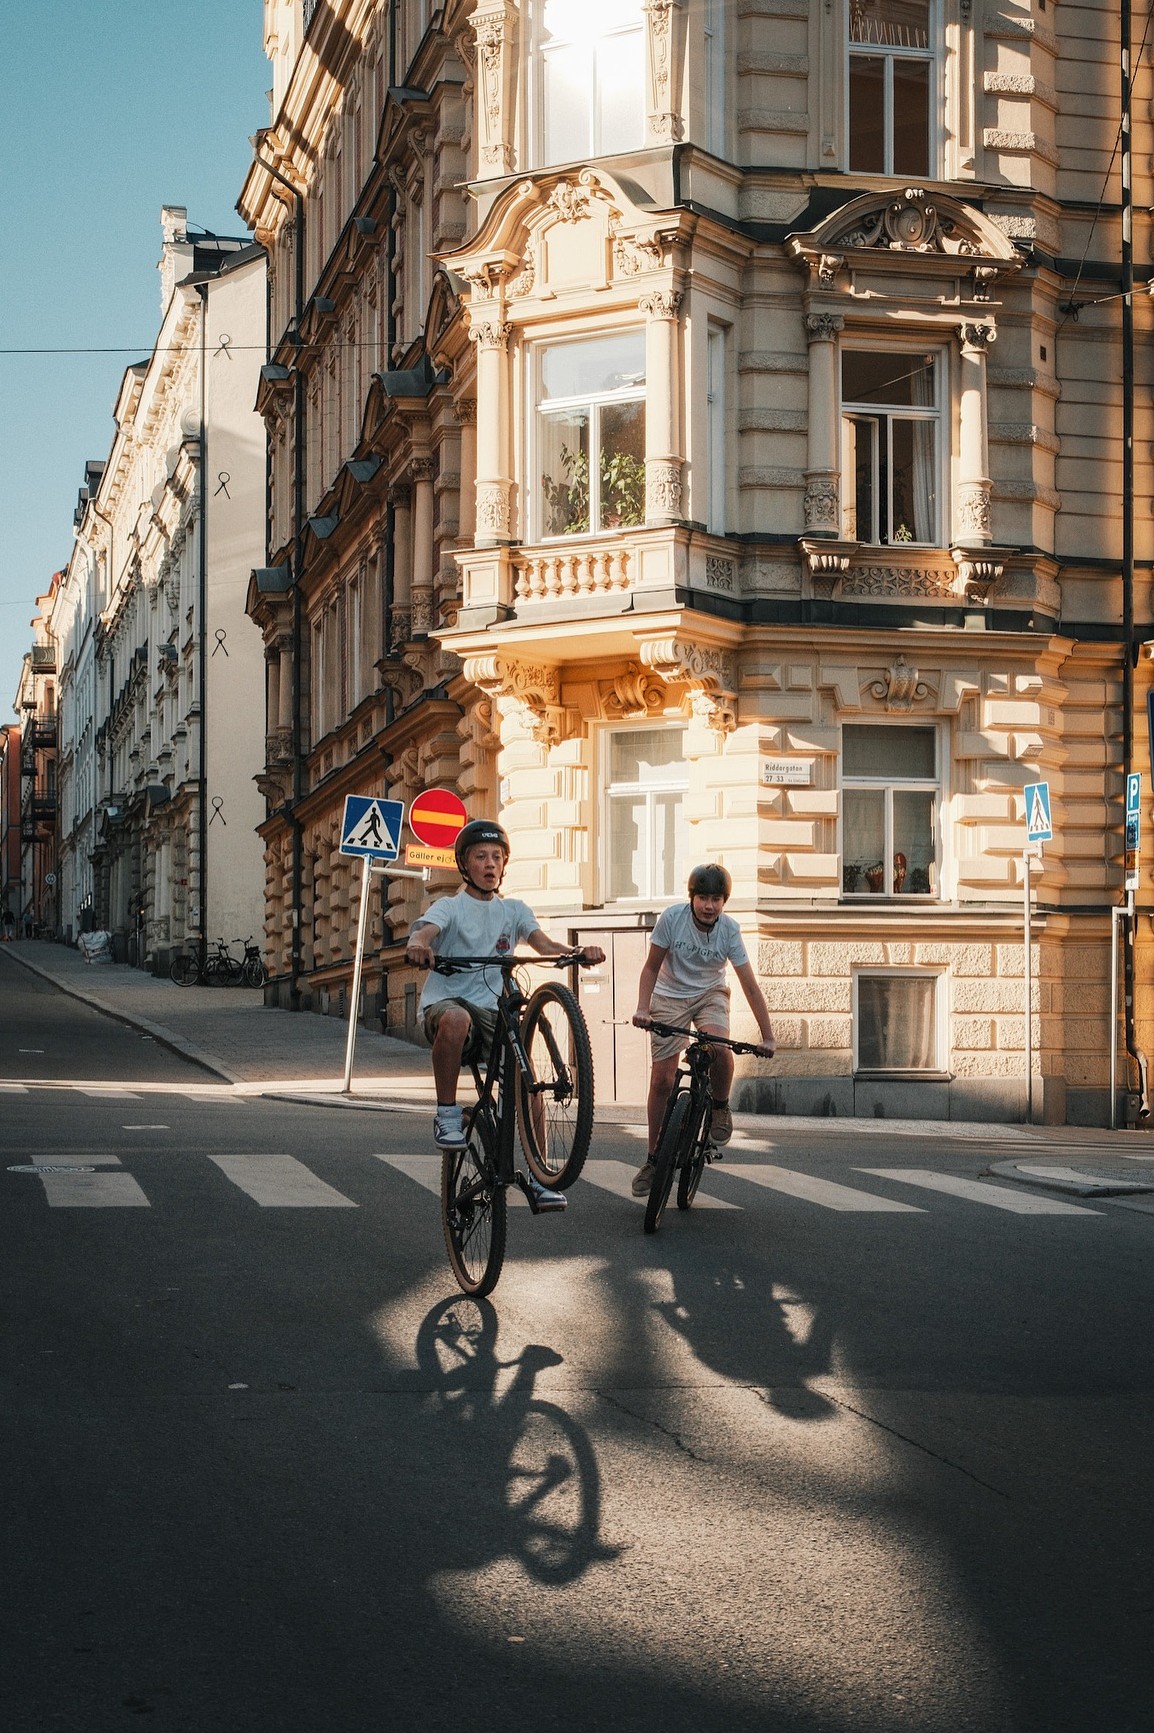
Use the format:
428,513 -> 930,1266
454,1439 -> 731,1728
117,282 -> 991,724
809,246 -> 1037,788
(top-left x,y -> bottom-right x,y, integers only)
400,1296 -> 617,1584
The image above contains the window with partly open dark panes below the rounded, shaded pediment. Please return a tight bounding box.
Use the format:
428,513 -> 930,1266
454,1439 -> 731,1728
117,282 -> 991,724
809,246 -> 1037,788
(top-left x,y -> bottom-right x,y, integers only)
842,348 -> 944,546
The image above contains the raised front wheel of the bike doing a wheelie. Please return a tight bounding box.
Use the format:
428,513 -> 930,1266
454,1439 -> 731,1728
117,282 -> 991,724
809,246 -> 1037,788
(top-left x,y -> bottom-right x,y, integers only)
516,981 -> 593,1191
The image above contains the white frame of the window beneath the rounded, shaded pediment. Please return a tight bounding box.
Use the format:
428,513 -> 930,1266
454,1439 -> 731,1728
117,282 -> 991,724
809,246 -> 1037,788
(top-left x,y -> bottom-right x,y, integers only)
837,334 -> 953,548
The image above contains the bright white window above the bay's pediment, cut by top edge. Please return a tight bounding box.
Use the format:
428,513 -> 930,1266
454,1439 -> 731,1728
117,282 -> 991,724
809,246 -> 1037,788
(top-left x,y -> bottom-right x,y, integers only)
535,0 -> 645,165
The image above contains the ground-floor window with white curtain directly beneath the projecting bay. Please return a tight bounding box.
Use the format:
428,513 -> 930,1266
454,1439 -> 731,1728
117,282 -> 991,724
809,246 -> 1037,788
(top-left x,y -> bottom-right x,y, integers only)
605,726 -> 690,903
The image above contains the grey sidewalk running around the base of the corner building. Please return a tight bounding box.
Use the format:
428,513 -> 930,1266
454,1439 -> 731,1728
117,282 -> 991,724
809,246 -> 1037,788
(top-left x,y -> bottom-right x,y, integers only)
0,939 -> 1154,1215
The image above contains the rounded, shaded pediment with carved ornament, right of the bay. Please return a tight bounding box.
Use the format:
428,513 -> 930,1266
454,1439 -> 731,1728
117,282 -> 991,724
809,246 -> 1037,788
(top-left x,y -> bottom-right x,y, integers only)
788,187 -> 1022,300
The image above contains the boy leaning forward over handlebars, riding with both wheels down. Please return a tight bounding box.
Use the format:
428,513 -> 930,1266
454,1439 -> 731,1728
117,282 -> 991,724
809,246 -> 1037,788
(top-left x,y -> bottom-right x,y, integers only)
632,865 -> 776,1198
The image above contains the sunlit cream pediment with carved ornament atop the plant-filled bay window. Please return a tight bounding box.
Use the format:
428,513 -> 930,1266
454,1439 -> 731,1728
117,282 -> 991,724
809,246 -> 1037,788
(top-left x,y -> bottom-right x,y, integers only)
436,168 -> 681,302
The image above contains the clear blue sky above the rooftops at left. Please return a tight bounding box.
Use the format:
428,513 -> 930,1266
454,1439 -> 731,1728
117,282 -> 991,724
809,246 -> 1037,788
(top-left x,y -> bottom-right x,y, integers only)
0,0 -> 272,723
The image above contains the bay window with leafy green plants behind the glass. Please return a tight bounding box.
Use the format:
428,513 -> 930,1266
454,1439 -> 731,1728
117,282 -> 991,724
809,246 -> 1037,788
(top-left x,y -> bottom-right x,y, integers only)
534,331 -> 645,539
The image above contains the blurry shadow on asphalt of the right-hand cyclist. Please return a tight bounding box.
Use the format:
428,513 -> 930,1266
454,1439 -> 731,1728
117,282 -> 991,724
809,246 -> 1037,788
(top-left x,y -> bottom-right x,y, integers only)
637,1248 -> 839,1421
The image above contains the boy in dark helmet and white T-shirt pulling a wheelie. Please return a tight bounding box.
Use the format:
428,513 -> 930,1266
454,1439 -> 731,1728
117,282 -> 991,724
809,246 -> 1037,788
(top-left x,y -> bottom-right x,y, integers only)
405,818 -> 605,1149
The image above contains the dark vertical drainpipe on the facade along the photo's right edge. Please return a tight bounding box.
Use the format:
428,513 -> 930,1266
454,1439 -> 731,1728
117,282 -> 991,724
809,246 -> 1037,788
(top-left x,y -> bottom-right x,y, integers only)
1119,0 -> 1151,1120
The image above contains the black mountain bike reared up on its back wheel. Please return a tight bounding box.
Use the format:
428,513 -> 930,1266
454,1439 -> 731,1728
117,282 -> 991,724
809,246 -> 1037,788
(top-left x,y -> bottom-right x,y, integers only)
431,951 -> 593,1296
